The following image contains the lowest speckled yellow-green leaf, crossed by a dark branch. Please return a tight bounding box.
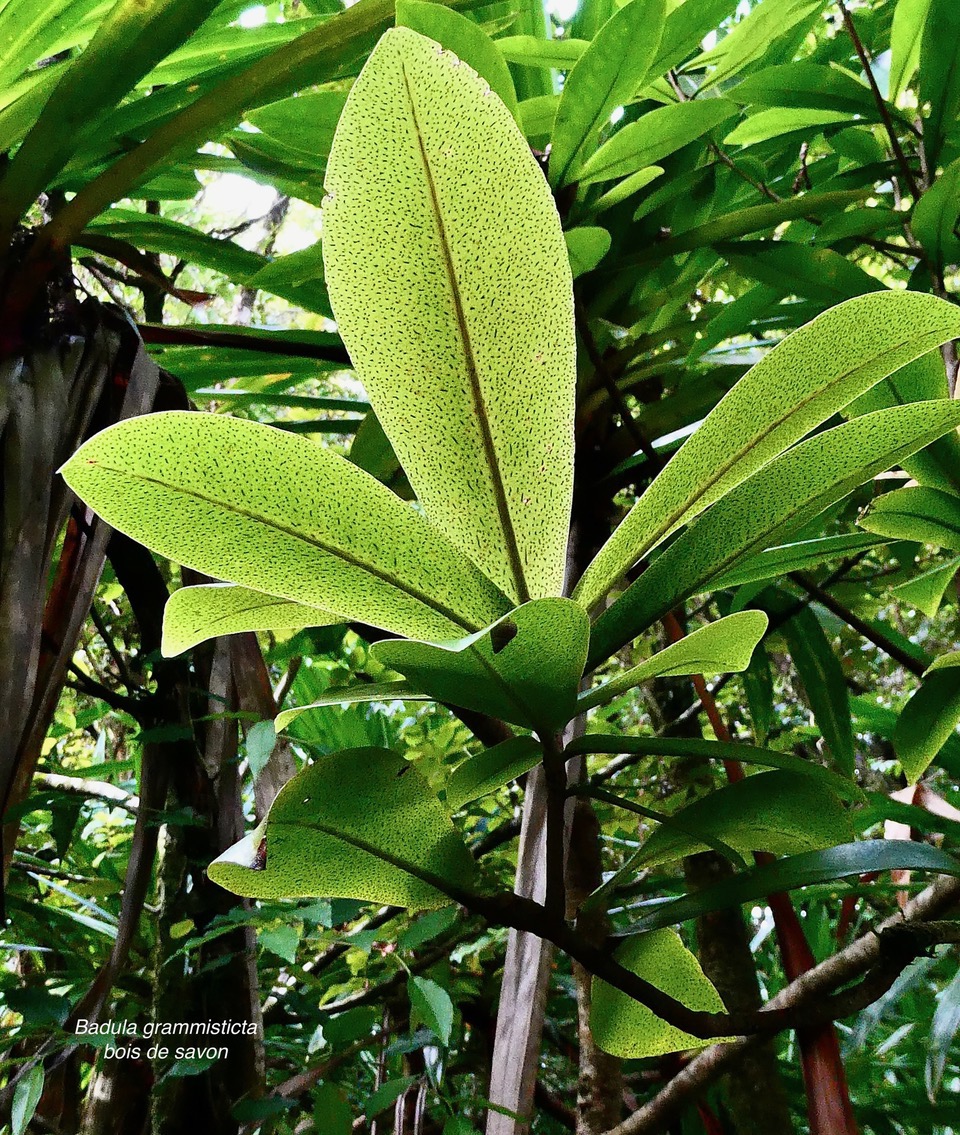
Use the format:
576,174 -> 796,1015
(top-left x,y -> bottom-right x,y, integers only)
590,930 -> 724,1060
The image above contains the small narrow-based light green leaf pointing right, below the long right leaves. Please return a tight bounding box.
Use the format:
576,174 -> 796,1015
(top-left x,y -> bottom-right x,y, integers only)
579,611 -> 768,712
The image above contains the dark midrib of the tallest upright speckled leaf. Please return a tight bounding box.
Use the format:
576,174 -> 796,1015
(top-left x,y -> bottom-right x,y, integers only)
401,60 -> 530,603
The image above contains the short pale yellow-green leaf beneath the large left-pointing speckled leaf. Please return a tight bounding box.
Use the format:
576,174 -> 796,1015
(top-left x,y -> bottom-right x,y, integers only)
161,583 -> 344,658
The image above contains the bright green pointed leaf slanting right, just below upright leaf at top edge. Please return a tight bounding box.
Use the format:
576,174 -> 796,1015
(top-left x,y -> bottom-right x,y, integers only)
578,98 -> 738,185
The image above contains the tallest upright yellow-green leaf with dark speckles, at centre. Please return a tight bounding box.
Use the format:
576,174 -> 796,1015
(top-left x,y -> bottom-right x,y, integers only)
323,27 -> 575,600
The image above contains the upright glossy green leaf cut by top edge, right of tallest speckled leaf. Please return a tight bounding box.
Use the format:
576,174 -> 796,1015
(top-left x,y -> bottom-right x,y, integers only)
550,0 -> 666,186
